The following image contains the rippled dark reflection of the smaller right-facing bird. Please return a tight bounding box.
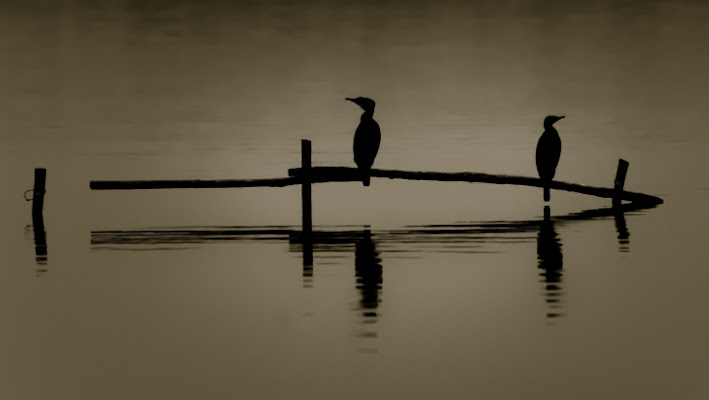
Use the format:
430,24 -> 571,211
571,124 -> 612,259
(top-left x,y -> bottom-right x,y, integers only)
537,206 -> 564,318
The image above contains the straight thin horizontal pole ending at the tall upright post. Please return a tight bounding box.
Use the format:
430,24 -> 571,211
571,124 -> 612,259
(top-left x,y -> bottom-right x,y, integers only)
90,177 -> 300,190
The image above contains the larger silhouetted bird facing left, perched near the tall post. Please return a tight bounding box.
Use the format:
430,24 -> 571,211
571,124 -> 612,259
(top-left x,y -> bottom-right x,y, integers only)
345,97 -> 382,186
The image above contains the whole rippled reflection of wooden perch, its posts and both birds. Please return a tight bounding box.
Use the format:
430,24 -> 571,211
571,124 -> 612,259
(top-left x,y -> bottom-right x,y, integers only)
91,204 -> 652,328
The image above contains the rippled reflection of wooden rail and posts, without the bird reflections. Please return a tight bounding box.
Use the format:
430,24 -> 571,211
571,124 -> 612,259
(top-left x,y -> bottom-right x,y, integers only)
91,204 -> 653,256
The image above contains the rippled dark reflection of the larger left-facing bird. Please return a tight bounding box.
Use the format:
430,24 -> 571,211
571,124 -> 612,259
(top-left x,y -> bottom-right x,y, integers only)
355,230 -> 383,352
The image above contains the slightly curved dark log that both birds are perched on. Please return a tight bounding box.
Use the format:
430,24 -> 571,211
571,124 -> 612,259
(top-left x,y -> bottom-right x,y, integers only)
288,167 -> 663,204
